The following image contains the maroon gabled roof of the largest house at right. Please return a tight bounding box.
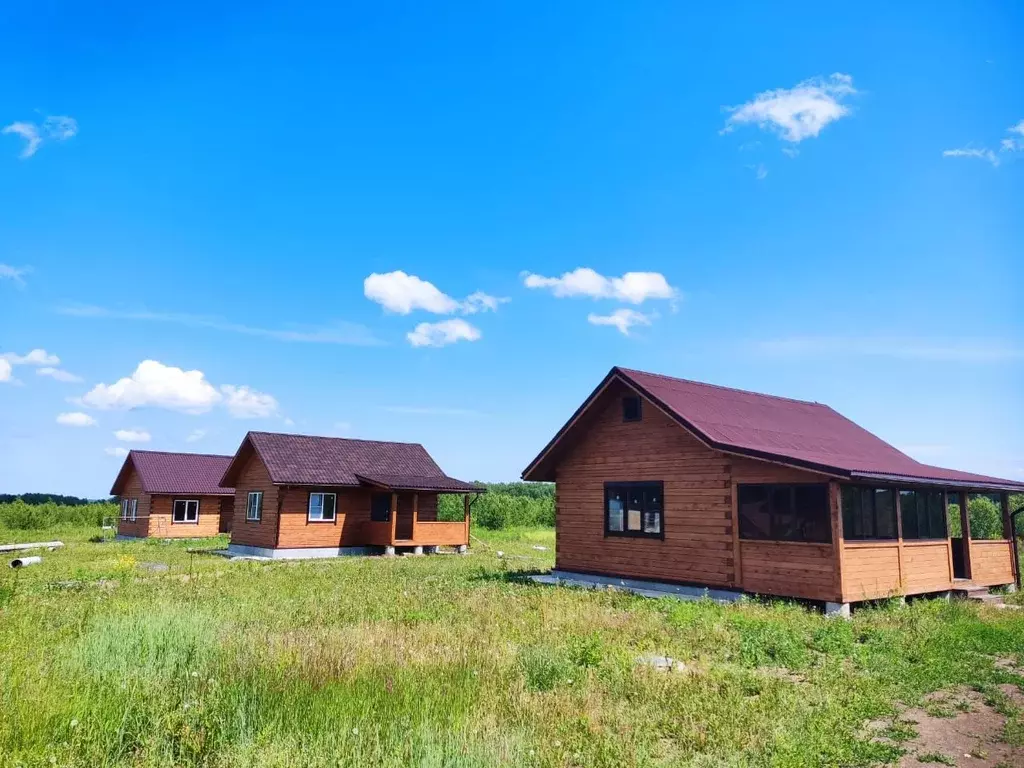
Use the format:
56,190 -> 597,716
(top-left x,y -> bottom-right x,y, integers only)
523,368 -> 1024,489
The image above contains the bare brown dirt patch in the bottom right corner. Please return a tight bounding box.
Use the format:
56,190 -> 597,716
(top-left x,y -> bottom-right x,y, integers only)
871,685 -> 1024,768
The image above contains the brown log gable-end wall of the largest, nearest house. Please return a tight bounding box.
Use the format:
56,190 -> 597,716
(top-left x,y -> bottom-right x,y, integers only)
555,384 -> 736,586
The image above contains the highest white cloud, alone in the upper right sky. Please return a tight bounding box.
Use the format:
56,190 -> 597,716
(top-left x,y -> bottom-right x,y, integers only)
722,73 -> 857,143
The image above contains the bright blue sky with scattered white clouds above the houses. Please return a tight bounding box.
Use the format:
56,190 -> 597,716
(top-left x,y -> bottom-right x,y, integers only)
0,2 -> 1024,496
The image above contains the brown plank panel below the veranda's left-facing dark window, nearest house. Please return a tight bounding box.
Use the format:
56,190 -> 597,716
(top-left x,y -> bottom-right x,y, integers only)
739,541 -> 839,602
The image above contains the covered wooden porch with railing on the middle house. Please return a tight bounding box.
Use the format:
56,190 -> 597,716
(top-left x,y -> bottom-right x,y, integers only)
358,475 -> 484,554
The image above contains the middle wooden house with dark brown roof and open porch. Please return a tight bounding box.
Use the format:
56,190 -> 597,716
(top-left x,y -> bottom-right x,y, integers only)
221,432 -> 483,558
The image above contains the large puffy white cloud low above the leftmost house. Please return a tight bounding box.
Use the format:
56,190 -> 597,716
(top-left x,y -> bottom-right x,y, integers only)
82,360 -> 220,414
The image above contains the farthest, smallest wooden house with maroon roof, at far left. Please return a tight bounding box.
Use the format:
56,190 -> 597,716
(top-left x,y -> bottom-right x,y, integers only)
111,451 -> 234,539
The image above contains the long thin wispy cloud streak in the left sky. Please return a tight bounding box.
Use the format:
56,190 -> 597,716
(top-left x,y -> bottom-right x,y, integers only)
57,304 -> 381,346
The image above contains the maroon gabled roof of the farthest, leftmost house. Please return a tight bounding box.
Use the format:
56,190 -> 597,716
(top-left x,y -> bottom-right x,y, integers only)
111,451 -> 234,496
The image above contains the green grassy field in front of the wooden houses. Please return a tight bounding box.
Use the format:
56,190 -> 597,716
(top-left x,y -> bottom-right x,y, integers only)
0,526 -> 1024,768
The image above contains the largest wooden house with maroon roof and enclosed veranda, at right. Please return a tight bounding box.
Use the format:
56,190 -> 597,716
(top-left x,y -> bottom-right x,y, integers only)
522,368 -> 1024,612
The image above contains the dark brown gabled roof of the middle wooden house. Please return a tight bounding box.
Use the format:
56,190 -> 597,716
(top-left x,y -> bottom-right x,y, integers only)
221,432 -> 481,493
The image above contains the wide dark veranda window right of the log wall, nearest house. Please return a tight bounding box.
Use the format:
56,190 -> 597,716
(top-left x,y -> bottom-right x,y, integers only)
736,483 -> 831,543
